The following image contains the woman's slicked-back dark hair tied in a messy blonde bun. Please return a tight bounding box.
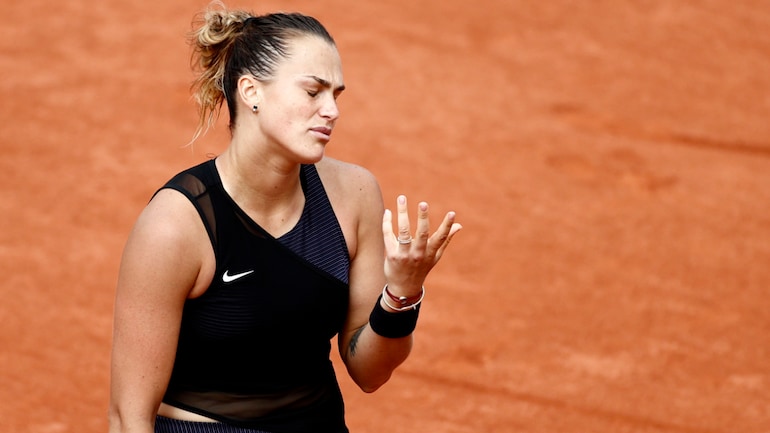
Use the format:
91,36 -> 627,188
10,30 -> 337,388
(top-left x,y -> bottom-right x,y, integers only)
190,1 -> 334,142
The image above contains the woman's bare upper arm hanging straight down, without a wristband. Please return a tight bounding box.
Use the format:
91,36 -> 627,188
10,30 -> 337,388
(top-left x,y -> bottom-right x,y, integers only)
111,190 -> 213,420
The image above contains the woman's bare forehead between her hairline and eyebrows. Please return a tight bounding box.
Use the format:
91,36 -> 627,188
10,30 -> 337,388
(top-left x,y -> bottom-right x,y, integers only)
276,36 -> 342,85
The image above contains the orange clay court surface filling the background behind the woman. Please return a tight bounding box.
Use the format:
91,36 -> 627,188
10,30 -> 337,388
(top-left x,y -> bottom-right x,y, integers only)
0,0 -> 770,433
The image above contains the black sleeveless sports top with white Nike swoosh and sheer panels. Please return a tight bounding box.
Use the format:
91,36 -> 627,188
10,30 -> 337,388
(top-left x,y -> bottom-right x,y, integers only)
161,160 -> 350,433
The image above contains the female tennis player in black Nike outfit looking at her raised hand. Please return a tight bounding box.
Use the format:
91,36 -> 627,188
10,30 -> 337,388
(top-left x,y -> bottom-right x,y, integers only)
109,4 -> 461,433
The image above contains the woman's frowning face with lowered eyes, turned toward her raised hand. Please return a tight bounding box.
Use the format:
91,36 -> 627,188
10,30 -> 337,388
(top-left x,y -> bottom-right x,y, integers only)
254,36 -> 345,164
